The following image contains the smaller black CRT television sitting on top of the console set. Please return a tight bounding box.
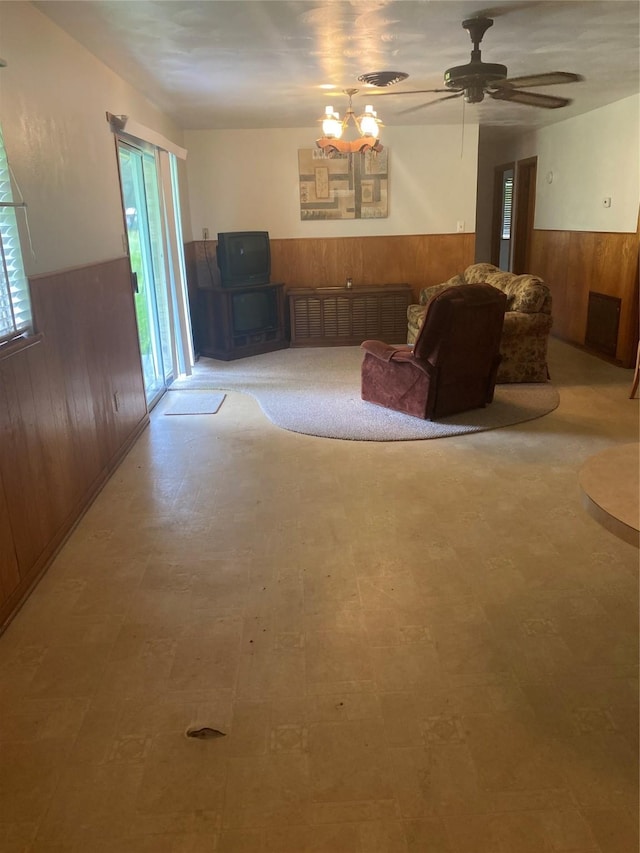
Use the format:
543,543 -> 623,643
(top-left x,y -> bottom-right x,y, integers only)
216,231 -> 271,287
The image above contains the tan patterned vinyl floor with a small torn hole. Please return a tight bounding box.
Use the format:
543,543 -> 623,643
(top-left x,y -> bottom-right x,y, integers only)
0,341 -> 638,853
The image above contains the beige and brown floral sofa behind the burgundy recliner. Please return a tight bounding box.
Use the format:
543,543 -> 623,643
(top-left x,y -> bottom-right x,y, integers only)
407,264 -> 552,383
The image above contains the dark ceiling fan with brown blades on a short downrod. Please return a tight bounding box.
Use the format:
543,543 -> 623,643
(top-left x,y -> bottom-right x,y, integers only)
358,17 -> 584,113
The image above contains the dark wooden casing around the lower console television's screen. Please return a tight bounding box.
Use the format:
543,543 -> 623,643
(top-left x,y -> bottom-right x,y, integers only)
196,282 -> 289,361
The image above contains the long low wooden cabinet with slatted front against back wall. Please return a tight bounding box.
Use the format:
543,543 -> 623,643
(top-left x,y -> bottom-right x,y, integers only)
288,284 -> 411,347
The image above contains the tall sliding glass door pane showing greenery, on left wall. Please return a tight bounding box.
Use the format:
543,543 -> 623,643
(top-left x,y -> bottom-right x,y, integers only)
118,140 -> 173,407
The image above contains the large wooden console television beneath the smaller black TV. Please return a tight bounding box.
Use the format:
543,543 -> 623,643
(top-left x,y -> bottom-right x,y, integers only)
196,283 -> 289,361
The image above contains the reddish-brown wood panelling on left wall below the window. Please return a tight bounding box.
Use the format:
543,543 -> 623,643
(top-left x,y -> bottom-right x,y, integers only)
0,258 -> 149,626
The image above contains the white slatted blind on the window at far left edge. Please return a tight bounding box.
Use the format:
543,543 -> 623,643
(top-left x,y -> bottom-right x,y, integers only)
0,128 -> 31,343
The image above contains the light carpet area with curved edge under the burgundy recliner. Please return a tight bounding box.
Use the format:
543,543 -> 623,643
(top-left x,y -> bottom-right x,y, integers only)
171,347 -> 560,441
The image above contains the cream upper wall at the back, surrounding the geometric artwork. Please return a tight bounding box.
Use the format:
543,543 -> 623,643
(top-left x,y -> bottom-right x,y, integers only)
184,125 -> 478,239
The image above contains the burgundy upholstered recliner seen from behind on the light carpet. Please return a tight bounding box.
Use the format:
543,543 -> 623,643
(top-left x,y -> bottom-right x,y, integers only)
361,284 -> 507,420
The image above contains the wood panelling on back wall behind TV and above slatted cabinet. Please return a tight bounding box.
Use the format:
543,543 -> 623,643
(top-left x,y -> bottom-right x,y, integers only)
186,234 -> 475,302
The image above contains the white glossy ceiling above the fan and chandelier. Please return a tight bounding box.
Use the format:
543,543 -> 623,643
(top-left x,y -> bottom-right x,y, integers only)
34,0 -> 640,129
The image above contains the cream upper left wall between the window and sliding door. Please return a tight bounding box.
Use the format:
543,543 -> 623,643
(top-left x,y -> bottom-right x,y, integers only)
0,2 -> 189,275
